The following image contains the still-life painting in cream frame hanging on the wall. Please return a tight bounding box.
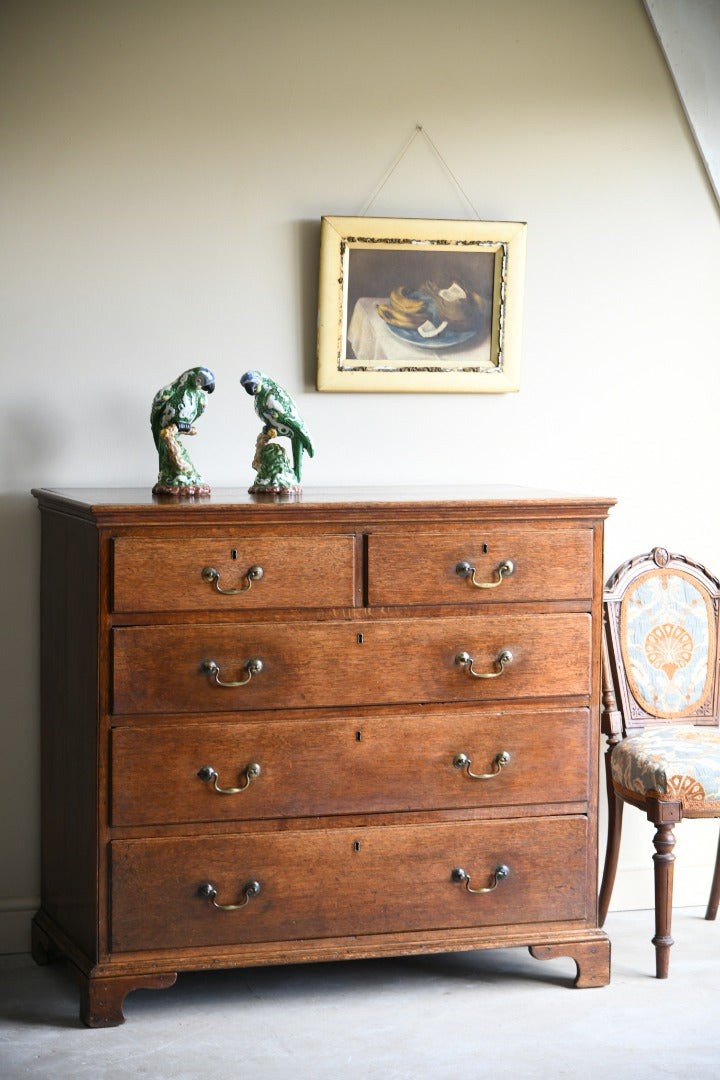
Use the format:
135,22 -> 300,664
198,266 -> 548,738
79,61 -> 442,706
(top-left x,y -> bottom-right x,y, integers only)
317,217 -> 527,393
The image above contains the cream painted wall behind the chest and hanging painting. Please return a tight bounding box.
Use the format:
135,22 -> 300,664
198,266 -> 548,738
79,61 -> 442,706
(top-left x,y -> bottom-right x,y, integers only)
0,0 -> 720,949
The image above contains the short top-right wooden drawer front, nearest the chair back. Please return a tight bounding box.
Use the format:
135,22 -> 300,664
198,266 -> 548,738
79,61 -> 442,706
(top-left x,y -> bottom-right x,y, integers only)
368,525 -> 593,606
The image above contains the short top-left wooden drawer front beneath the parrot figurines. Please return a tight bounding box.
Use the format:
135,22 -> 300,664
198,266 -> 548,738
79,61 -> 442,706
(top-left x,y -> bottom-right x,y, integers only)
113,535 -> 355,611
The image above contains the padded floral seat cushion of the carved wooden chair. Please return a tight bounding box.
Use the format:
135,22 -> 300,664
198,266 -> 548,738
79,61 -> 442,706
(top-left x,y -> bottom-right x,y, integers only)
610,725 -> 720,812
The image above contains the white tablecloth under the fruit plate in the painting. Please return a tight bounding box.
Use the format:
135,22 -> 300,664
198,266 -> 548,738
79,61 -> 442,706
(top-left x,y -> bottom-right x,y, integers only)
348,296 -> 493,370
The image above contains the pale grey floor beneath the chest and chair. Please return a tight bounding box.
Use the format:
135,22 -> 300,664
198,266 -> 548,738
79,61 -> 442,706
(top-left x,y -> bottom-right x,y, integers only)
0,908 -> 720,1080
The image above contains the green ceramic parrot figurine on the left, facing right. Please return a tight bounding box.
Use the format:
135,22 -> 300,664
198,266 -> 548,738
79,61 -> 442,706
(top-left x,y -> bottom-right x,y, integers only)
150,367 -> 215,495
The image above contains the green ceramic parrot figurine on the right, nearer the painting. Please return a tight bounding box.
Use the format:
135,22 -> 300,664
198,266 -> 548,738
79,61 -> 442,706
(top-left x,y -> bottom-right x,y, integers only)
240,372 -> 315,491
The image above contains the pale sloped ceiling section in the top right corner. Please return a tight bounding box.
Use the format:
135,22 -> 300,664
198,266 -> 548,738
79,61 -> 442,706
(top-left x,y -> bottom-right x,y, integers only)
644,0 -> 720,204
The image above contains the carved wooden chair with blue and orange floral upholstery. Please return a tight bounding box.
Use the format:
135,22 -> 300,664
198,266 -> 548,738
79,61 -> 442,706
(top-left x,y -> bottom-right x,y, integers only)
599,548 -> 720,978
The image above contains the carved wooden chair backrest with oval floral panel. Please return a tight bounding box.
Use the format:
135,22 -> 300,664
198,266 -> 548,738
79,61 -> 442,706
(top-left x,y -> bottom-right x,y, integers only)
604,548 -> 720,733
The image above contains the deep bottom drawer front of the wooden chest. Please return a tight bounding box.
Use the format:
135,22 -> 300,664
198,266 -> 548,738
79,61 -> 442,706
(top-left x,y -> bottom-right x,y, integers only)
111,816 -> 587,951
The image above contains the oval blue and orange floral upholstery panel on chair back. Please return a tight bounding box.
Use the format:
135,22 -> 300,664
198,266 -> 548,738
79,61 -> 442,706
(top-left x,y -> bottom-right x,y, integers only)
621,569 -> 716,719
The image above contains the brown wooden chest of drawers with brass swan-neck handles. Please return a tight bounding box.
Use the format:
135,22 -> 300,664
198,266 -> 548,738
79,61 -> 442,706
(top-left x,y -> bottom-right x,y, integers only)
33,488 -> 610,1026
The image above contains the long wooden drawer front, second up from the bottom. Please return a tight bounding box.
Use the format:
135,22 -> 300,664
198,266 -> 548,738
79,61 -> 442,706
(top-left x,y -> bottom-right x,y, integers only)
111,710 -> 588,826
